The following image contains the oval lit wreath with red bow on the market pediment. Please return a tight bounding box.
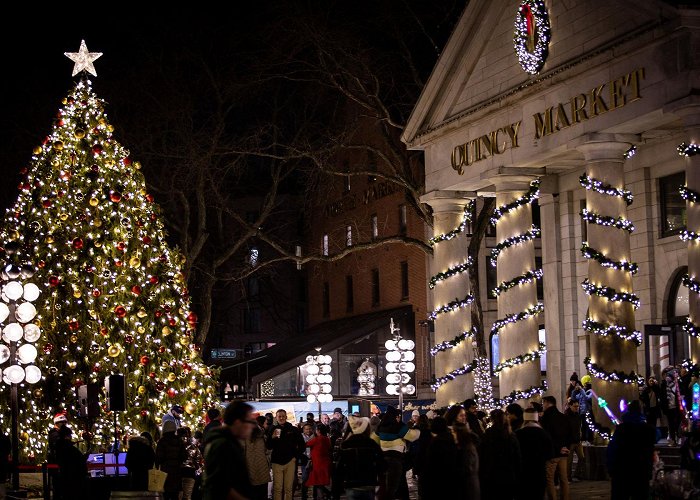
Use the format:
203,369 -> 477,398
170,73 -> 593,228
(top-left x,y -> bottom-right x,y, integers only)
513,0 -> 550,75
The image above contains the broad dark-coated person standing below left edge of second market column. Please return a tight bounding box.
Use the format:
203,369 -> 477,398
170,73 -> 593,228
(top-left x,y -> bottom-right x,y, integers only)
479,409 -> 522,500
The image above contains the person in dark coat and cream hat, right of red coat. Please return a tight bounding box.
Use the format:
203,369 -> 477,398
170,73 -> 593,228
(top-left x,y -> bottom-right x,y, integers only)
337,415 -> 387,500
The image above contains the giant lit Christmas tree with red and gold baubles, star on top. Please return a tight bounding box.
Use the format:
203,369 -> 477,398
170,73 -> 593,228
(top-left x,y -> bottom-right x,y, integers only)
0,42 -> 217,458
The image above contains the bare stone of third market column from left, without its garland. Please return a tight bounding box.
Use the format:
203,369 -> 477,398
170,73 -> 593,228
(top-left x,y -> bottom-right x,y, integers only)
578,134 -> 639,428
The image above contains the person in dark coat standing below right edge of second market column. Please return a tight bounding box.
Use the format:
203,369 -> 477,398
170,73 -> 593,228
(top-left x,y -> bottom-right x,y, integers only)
515,408 -> 554,500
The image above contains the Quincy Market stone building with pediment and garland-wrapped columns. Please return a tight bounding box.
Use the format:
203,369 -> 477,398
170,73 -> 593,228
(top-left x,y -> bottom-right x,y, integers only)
403,0 -> 700,422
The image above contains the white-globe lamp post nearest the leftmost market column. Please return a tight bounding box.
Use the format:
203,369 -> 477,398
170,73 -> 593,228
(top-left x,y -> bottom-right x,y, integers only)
384,318 -> 416,418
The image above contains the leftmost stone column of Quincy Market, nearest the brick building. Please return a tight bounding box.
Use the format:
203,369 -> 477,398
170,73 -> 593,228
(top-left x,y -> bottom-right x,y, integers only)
421,191 -> 475,406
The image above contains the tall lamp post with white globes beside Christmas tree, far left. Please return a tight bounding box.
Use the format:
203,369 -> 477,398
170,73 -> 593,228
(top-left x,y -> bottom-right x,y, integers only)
0,245 -> 41,491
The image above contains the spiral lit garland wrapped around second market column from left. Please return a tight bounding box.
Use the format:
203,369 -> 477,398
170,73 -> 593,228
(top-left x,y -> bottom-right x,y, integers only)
490,179 -> 547,404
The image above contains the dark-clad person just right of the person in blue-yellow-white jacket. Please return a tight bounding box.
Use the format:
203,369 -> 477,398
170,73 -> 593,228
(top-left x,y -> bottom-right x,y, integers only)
418,417 -> 461,498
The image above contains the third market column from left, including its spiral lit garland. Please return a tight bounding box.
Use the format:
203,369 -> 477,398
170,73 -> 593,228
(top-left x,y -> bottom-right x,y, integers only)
579,136 -> 641,437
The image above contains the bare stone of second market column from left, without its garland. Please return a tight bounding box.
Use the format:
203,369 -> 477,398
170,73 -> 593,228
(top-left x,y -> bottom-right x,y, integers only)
492,175 -> 541,399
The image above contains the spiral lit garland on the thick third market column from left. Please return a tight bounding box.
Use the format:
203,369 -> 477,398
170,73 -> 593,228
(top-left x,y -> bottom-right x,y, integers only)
579,171 -> 644,439
